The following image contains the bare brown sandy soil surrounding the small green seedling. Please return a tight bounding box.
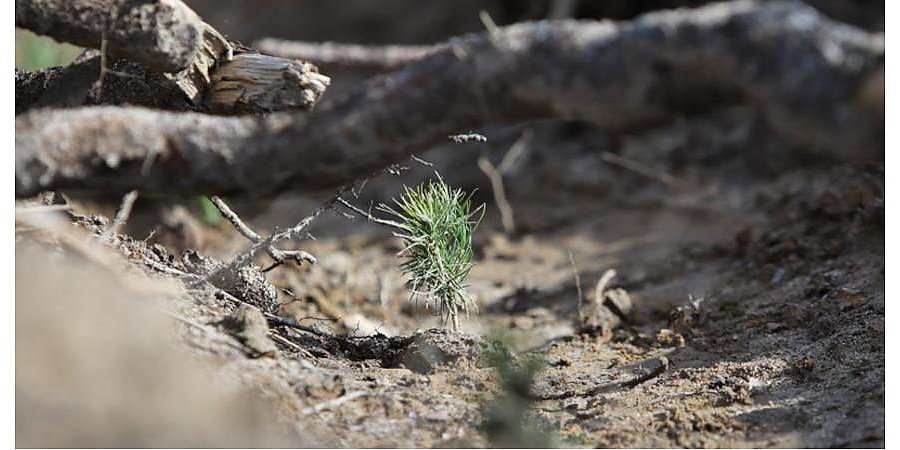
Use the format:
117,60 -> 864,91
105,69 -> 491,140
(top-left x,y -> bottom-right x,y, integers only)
16,101 -> 885,447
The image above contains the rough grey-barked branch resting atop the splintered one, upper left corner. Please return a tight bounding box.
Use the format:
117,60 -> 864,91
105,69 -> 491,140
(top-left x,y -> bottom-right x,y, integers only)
16,0 -> 204,72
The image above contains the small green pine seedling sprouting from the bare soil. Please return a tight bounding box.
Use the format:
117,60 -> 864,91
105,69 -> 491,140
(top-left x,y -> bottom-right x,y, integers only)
378,175 -> 484,331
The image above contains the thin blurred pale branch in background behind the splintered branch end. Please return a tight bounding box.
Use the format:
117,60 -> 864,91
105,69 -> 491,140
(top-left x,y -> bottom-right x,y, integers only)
253,38 -> 445,72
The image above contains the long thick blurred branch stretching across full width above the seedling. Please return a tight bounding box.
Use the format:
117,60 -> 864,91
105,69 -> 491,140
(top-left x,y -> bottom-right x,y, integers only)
16,0 -> 884,197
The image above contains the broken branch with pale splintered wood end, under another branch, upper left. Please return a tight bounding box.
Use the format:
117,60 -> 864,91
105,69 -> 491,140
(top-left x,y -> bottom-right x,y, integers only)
16,46 -> 331,115
